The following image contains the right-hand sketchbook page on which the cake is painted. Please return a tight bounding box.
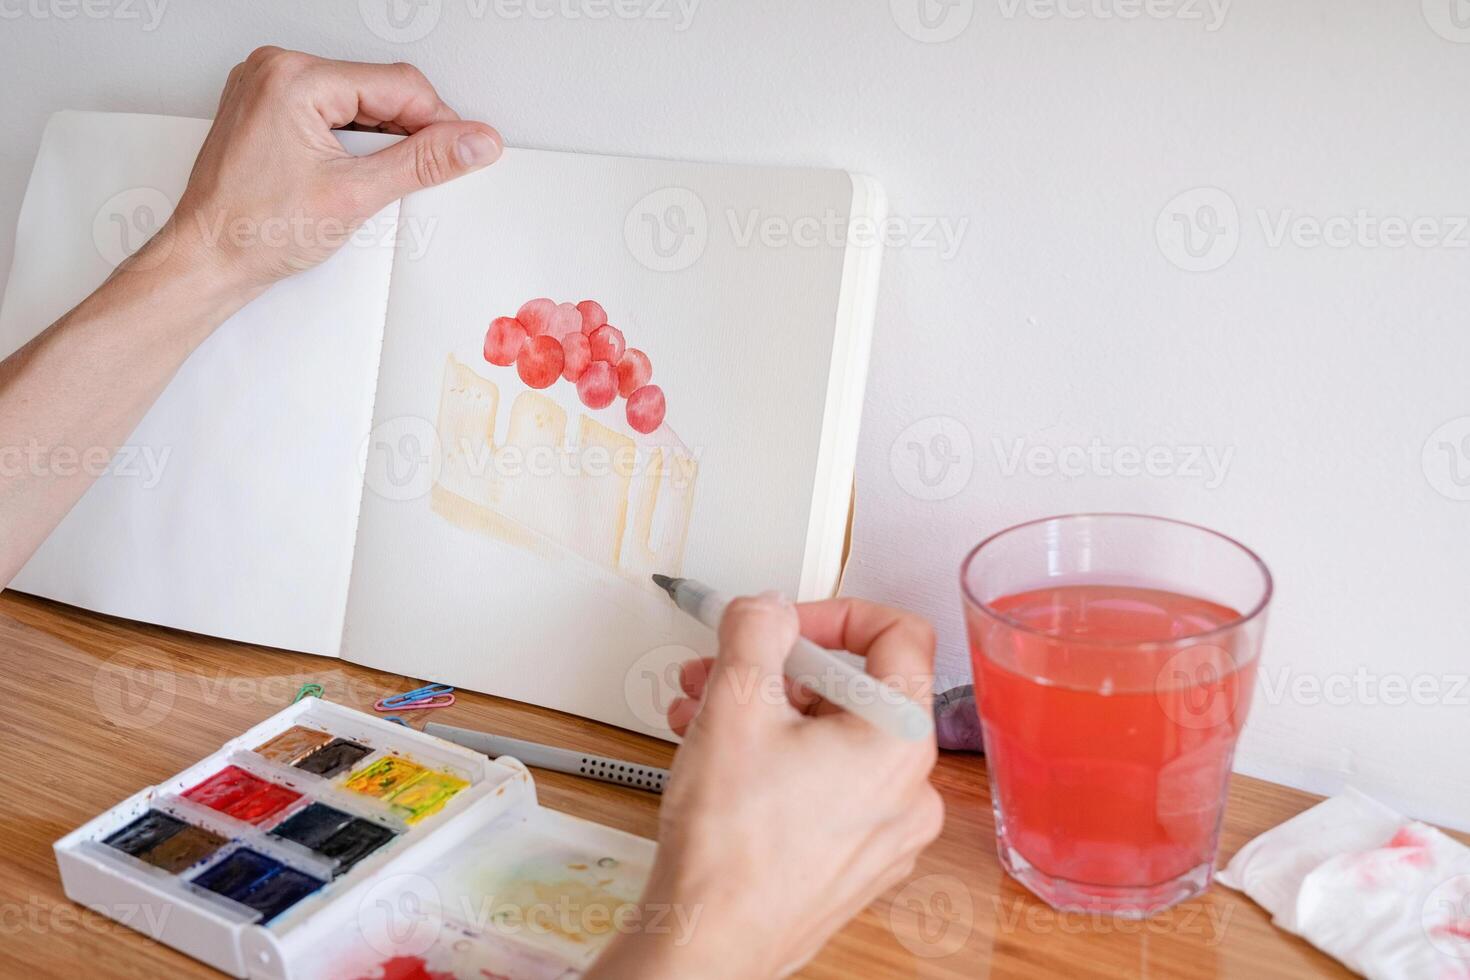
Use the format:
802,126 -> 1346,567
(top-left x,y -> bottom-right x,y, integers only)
343,150 -> 853,736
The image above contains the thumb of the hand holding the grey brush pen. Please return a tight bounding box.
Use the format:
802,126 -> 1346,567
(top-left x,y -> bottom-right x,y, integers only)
700,592 -> 801,724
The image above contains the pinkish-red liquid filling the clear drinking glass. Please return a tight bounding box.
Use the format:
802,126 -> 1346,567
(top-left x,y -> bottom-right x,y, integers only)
970,585 -> 1255,887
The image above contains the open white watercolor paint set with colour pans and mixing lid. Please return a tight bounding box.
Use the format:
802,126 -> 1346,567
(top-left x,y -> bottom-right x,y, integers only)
54,698 -> 654,980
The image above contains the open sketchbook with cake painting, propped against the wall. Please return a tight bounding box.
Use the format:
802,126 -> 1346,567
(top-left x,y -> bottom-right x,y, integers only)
0,112 -> 883,736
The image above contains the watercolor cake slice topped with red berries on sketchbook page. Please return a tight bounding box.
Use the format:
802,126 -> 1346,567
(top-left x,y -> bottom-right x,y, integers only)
431,298 -> 698,588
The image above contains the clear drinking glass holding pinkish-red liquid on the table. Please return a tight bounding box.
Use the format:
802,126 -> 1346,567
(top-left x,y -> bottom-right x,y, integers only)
960,514 -> 1272,918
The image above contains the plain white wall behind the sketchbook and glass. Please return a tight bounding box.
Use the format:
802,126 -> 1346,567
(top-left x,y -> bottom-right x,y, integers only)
0,0 -> 1470,827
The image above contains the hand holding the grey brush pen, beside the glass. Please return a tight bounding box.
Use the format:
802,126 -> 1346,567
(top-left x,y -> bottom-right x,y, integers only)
588,595 -> 944,980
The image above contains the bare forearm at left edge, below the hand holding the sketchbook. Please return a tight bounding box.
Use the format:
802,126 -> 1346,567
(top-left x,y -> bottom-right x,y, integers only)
0,226 -> 251,586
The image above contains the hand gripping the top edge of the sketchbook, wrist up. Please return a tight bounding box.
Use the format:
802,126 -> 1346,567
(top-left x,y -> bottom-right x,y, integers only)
148,47 -> 501,304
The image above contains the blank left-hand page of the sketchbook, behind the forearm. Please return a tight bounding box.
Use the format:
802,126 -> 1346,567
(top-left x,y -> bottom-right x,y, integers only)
0,113 -> 397,655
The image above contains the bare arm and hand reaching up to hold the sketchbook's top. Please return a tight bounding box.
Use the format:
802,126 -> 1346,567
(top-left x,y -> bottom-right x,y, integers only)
0,47 -> 501,586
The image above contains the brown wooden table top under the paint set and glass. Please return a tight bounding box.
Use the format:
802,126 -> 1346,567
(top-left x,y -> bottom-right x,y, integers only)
0,592 -> 1405,980
